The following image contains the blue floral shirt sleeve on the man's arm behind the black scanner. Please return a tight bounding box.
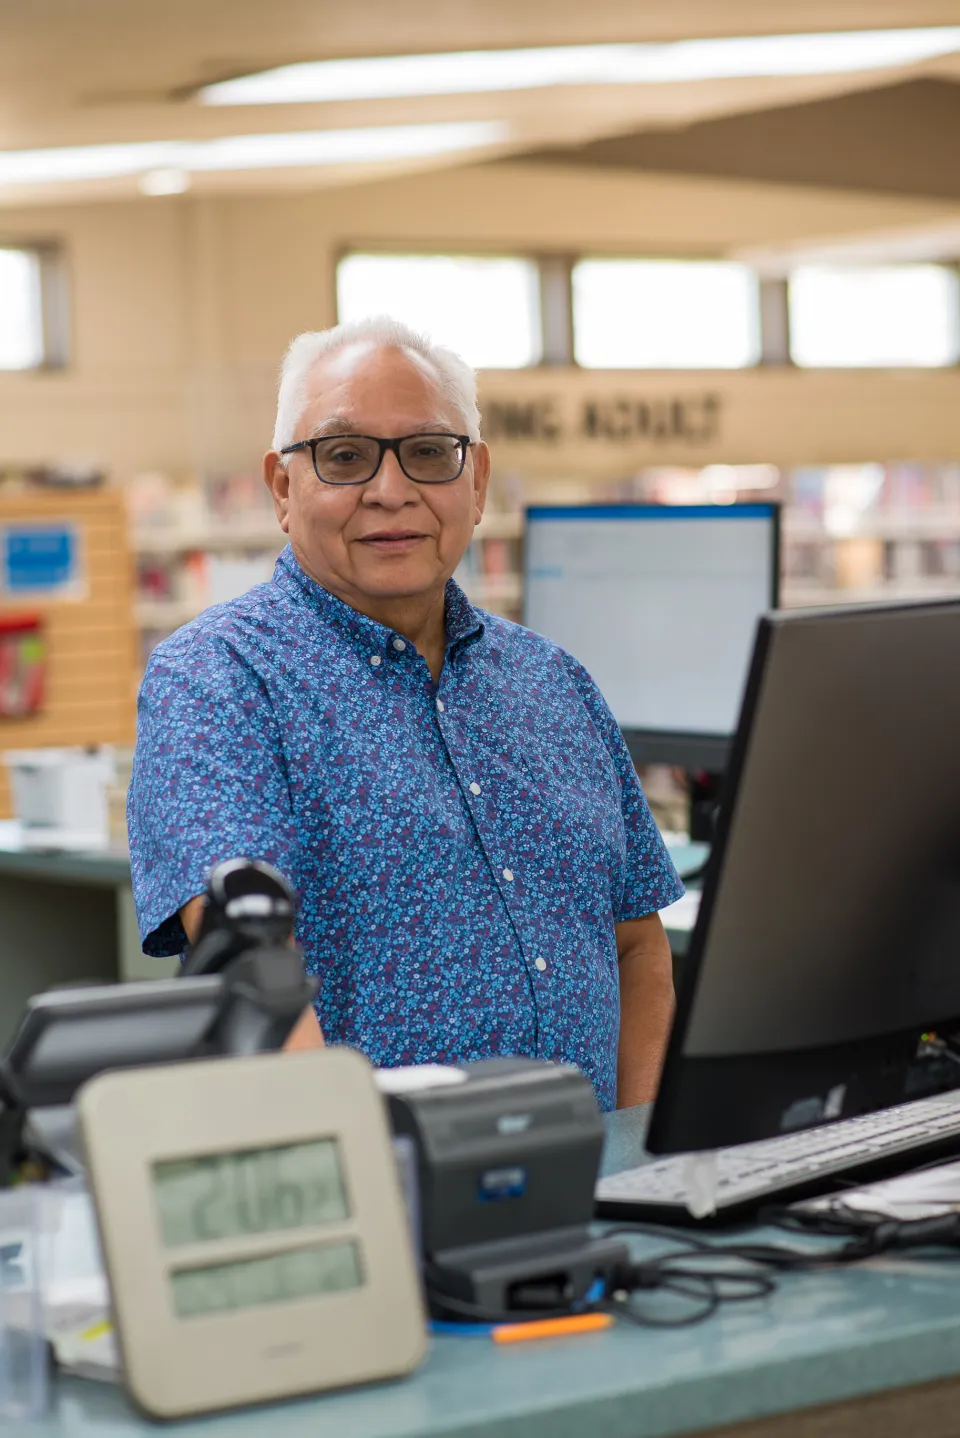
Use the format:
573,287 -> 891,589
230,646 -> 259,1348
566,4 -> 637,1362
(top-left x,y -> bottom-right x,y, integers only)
126,630 -> 295,956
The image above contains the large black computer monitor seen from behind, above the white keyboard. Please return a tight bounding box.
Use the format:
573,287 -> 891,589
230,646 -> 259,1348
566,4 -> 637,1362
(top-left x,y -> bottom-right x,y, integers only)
647,600 -> 960,1153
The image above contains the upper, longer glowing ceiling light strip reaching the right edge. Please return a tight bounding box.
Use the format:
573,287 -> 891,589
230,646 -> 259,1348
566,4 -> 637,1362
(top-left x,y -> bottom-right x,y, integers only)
198,26 -> 960,105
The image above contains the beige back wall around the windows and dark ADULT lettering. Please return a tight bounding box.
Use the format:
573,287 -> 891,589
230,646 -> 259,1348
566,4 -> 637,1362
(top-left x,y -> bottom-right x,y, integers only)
0,164 -> 960,479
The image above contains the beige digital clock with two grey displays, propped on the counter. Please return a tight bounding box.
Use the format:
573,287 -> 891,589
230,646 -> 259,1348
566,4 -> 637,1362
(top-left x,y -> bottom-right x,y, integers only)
78,1048 -> 425,1418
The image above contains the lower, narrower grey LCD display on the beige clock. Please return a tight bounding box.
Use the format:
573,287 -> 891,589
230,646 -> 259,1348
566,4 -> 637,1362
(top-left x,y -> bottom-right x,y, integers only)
170,1242 -> 364,1319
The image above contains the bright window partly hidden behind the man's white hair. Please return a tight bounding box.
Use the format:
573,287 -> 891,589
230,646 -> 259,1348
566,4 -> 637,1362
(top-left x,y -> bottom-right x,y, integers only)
336,255 -> 542,370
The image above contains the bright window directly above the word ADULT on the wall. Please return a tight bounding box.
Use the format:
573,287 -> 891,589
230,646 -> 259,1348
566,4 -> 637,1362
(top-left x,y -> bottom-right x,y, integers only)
573,260 -> 760,370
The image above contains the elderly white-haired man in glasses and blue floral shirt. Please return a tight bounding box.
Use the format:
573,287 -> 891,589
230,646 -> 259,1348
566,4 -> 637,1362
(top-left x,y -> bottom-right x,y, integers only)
129,319 -> 683,1109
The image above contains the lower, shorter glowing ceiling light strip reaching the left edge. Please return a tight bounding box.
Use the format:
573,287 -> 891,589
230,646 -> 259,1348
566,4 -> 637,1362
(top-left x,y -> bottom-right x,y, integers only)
0,121 -> 509,193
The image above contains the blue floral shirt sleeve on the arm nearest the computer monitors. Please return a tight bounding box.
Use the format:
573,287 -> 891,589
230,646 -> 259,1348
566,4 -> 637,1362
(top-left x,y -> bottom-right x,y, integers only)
565,656 -> 684,923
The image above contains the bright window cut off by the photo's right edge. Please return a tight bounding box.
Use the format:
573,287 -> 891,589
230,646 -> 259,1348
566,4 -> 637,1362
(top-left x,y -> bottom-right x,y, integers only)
790,265 -> 960,367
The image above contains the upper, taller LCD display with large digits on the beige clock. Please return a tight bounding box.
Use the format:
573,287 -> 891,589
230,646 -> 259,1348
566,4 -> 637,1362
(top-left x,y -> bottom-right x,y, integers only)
152,1139 -> 349,1248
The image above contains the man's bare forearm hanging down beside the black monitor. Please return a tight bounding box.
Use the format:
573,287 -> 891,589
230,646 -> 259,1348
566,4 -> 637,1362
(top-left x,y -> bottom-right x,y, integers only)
617,913 -> 674,1109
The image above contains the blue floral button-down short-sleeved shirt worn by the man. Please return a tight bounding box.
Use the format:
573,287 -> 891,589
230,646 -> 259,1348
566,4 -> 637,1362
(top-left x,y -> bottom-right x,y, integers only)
128,548 -> 683,1109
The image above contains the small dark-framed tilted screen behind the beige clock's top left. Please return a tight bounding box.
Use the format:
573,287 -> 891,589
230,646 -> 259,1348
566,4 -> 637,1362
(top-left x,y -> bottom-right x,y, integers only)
4,975 -> 223,1107
